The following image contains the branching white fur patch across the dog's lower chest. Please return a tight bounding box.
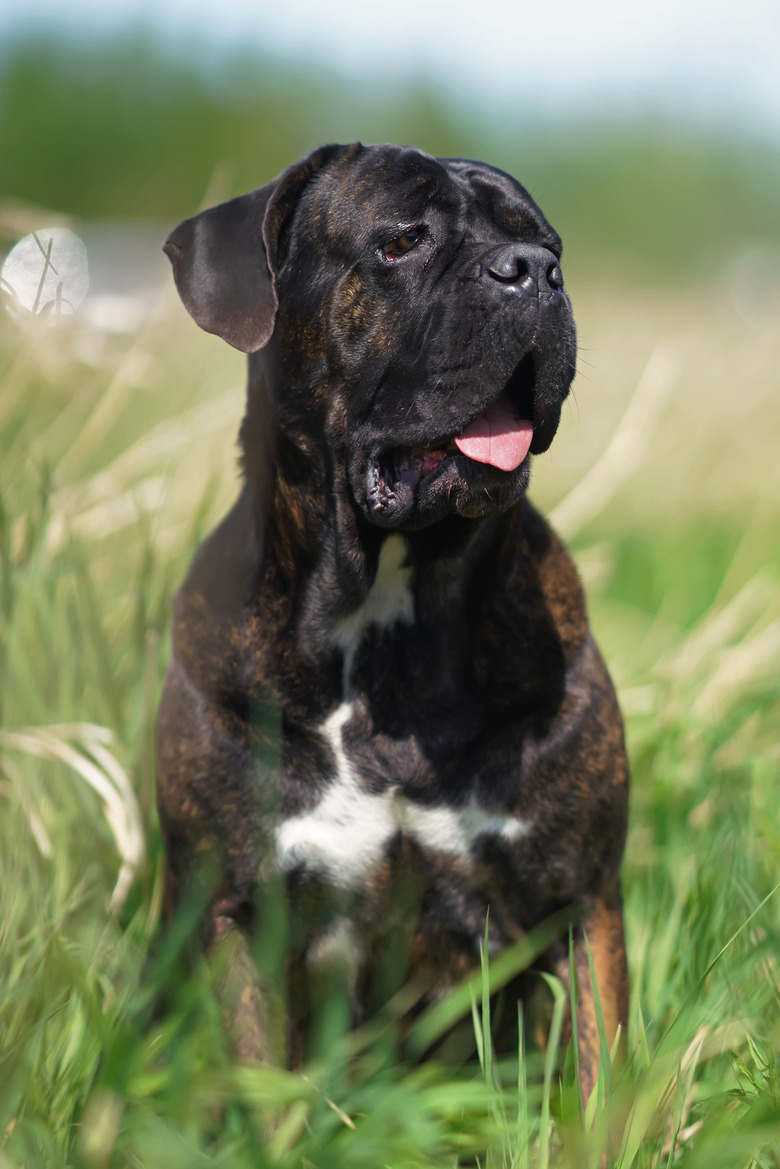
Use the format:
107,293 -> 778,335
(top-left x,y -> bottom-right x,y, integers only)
276,704 -> 532,890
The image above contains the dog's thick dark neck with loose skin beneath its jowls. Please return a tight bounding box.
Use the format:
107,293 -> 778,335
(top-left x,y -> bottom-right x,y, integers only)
241,352 -> 523,678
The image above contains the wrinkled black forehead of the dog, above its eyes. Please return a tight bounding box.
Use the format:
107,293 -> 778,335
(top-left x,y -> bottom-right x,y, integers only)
299,146 -> 557,251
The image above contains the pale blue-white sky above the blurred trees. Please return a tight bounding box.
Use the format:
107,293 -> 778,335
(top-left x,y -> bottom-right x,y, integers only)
0,0 -> 780,140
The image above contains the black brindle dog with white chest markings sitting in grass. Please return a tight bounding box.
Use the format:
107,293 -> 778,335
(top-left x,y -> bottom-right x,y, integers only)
158,143 -> 628,1094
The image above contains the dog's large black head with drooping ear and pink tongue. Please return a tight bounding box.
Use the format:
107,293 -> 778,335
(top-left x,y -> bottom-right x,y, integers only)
165,144 -> 575,531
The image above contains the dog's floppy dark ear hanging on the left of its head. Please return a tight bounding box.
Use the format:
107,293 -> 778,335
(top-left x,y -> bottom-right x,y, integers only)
164,146 -> 352,353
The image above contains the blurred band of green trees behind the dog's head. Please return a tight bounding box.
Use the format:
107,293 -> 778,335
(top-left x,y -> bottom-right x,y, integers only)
0,27 -> 780,282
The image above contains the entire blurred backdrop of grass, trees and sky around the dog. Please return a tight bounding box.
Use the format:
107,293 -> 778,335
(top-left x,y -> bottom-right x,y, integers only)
0,0 -> 780,1169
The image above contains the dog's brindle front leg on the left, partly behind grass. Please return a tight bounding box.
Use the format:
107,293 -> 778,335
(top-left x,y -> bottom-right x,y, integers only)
158,640 -> 287,1066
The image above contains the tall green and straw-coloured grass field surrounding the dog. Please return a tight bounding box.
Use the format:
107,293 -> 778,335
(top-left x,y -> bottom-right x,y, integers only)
0,265 -> 780,1169
